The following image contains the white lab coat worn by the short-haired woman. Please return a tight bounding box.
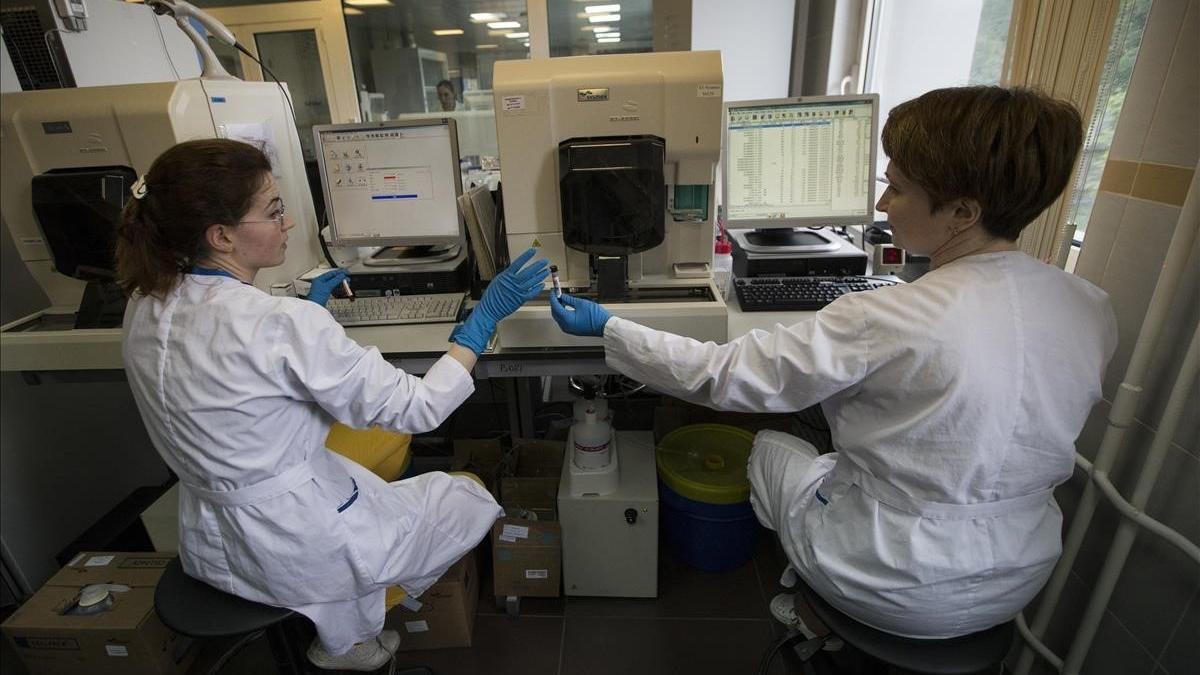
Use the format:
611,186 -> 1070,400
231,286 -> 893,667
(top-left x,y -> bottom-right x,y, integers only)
605,252 -> 1116,638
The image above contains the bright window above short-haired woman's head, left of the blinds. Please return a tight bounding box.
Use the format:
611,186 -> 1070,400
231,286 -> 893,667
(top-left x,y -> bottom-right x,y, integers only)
863,0 -> 1013,178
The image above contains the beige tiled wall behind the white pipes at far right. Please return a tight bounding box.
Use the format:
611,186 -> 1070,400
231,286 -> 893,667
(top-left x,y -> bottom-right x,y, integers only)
1027,0 -> 1200,675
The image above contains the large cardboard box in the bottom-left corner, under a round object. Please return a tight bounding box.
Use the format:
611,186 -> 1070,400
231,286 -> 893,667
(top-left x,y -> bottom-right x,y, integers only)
2,552 -> 198,675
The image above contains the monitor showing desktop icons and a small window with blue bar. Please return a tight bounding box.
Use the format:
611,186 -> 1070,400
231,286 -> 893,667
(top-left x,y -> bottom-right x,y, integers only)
313,118 -> 463,246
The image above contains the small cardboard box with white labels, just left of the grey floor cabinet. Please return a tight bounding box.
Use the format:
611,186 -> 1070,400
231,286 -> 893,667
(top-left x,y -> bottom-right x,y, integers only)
492,518 -> 563,598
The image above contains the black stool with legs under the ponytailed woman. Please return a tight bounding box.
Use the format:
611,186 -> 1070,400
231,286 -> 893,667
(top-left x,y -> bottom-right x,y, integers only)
154,557 -> 306,675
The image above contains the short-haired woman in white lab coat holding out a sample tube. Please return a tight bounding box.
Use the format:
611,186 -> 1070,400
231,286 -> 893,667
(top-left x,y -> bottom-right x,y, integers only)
550,86 -> 1116,638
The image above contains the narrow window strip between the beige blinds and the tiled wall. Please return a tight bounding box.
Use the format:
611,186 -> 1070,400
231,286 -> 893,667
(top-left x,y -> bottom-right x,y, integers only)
1067,0 -> 1152,265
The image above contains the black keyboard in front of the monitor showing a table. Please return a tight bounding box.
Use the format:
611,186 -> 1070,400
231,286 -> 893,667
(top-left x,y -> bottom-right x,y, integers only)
733,276 -> 895,312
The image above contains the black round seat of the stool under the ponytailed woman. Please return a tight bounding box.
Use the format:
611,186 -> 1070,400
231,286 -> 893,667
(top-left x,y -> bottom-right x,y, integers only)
154,557 -> 293,638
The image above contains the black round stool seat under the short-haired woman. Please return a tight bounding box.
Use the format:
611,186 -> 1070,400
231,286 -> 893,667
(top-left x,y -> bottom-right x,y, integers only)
796,583 -> 1014,675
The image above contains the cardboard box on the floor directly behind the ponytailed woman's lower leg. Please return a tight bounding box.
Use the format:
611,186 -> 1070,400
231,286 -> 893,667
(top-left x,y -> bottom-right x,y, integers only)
384,551 -> 479,651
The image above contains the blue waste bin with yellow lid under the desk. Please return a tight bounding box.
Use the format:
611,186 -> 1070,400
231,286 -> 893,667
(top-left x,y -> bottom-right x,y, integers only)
656,424 -> 757,572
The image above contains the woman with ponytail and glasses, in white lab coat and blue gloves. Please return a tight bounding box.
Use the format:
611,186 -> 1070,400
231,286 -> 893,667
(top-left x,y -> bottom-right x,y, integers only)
116,139 -> 546,670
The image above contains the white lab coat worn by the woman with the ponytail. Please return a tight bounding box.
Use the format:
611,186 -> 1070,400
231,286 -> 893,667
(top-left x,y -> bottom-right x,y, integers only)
122,274 -> 503,653
